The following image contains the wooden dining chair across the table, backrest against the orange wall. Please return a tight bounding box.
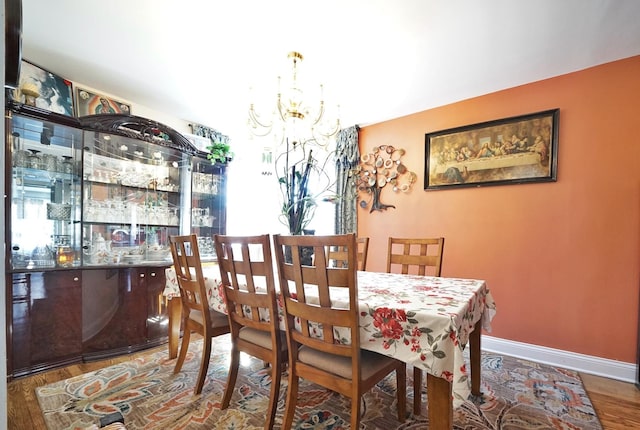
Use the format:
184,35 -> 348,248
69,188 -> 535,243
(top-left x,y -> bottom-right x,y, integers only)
387,237 -> 444,415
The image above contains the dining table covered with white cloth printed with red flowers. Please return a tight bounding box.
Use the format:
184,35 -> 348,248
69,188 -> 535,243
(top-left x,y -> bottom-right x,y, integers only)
163,263 -> 496,430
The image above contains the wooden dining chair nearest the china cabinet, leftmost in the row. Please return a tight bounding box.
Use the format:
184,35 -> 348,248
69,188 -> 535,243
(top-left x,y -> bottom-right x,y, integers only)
169,234 -> 230,394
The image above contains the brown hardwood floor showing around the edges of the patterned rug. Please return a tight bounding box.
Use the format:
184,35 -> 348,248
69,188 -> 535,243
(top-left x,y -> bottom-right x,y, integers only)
7,345 -> 640,430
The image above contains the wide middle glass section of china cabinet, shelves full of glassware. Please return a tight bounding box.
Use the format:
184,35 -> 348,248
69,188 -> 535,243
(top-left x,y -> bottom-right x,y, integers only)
82,131 -> 184,266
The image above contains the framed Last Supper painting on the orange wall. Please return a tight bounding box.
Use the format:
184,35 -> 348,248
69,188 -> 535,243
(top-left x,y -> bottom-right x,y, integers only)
424,109 -> 560,190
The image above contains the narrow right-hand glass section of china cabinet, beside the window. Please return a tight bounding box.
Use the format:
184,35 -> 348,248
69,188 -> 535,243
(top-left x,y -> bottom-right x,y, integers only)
191,157 -> 227,259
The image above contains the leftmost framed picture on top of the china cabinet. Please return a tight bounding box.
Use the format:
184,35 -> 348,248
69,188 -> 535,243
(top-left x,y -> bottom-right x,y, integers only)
13,60 -> 73,116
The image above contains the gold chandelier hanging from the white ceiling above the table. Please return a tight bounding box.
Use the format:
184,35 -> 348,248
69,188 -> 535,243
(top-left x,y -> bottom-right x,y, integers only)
247,52 -> 340,148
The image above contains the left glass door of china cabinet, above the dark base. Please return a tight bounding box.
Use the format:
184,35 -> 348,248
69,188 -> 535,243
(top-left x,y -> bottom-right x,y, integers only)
7,113 -> 82,270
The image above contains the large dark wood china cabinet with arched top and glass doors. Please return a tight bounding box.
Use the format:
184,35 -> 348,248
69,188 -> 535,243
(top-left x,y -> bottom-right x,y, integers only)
5,100 -> 226,377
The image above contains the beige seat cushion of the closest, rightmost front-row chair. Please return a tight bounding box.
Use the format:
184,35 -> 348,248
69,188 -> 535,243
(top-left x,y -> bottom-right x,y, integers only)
298,346 -> 394,380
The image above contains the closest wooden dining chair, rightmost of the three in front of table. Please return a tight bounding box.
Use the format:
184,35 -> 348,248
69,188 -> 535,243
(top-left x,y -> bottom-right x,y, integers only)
273,234 -> 407,429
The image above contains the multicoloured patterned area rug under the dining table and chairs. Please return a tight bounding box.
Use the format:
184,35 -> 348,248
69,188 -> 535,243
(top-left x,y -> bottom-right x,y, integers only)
36,335 -> 602,430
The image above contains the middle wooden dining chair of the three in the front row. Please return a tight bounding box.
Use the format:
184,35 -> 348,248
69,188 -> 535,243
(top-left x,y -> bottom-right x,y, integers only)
213,234 -> 287,429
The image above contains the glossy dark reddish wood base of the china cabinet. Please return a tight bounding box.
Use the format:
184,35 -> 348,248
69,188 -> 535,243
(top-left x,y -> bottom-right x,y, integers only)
6,267 -> 169,379
